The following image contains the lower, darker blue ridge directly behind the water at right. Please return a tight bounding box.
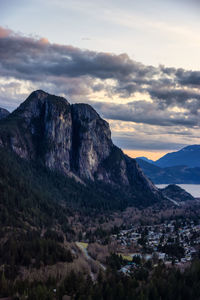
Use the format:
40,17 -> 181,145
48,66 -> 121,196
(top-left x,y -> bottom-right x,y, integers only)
136,158 -> 200,184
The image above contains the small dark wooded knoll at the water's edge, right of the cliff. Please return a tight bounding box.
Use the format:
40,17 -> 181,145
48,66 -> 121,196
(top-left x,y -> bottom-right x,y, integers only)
161,184 -> 194,202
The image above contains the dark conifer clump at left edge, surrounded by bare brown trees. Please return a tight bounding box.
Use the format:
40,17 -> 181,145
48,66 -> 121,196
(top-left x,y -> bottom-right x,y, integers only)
0,230 -> 74,282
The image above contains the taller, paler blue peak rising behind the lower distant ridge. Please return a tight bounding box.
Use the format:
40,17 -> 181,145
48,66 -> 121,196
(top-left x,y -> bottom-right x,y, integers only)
154,145 -> 200,168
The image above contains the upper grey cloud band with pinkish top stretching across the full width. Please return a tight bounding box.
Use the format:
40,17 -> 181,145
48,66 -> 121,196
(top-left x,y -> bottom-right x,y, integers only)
0,28 -> 200,103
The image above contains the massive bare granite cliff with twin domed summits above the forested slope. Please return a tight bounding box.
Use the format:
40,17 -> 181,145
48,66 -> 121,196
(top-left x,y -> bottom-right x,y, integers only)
0,91 -> 159,203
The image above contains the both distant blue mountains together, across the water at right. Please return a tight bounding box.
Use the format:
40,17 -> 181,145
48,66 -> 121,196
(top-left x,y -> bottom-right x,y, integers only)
136,145 -> 200,184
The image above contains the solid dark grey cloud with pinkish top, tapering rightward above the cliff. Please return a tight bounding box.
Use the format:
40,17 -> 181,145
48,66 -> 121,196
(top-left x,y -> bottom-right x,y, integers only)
0,29 -> 144,81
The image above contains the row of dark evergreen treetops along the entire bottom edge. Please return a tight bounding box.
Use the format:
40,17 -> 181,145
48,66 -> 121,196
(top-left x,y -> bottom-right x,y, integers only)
0,261 -> 200,300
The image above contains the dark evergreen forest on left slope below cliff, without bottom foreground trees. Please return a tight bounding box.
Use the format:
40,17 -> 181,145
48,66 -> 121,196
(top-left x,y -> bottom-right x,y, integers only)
0,149 -> 155,299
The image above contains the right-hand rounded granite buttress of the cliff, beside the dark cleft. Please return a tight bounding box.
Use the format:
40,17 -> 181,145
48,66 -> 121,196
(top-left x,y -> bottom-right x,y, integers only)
71,104 -> 113,180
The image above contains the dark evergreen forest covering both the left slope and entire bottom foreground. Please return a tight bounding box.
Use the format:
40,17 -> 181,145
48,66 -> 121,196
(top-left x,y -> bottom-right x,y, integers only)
0,144 -> 200,300
